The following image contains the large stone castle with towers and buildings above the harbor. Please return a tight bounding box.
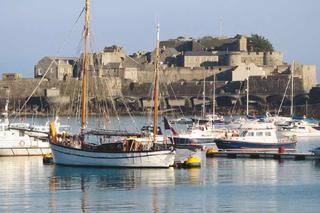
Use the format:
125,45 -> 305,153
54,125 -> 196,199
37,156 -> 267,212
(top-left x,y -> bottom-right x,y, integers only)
1,35 -> 317,115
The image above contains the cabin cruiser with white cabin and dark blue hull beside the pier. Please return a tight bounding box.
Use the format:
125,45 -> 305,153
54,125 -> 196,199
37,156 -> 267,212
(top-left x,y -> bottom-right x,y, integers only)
215,122 -> 297,149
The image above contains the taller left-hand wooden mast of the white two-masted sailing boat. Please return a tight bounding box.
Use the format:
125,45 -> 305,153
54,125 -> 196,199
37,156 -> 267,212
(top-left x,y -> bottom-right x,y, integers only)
81,0 -> 90,130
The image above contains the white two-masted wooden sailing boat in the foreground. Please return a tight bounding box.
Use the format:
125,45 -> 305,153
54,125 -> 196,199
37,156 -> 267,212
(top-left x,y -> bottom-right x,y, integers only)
49,0 -> 175,168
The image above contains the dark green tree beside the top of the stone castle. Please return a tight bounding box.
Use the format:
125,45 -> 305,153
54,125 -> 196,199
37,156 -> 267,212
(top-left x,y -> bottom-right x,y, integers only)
248,34 -> 274,52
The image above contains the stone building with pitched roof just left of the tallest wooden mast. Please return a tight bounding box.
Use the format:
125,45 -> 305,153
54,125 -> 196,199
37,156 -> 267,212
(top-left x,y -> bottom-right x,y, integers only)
34,56 -> 79,81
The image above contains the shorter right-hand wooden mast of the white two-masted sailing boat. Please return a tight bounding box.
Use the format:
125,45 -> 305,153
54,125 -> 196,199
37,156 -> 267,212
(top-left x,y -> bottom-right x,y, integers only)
153,24 -> 160,143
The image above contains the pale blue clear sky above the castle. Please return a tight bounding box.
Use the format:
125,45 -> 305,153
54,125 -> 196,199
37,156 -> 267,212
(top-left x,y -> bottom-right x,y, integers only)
0,0 -> 320,82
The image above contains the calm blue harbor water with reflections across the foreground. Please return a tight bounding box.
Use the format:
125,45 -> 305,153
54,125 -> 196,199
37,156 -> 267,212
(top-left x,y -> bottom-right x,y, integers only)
0,118 -> 320,212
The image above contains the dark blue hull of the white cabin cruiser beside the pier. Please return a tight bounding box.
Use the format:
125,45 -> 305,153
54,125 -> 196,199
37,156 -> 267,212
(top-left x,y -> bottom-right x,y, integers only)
215,139 -> 297,149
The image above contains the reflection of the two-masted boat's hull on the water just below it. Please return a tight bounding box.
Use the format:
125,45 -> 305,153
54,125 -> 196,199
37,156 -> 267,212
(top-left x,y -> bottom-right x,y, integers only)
50,166 -> 175,190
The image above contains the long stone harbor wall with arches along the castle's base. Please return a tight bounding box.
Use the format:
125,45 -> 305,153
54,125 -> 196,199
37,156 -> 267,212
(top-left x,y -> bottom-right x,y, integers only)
0,75 -> 320,117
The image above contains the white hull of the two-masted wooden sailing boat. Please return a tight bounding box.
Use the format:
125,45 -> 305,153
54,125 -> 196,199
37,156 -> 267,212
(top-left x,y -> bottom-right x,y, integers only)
50,143 -> 175,168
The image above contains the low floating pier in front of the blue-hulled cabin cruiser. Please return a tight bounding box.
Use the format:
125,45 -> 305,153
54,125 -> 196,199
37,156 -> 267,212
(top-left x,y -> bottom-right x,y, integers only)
206,151 -> 320,160
